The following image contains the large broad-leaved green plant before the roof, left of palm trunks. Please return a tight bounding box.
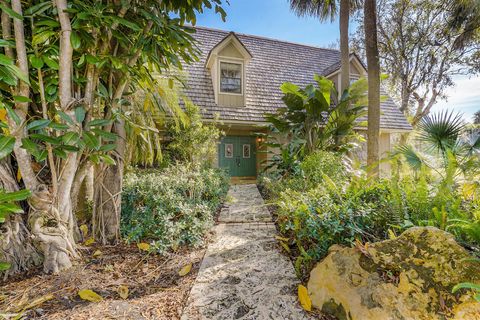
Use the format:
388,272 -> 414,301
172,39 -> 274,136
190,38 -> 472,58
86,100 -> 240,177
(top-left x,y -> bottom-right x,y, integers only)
266,75 -> 366,155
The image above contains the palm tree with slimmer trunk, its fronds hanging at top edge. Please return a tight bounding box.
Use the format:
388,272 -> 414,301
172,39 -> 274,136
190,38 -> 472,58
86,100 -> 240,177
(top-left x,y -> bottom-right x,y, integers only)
290,0 -> 357,91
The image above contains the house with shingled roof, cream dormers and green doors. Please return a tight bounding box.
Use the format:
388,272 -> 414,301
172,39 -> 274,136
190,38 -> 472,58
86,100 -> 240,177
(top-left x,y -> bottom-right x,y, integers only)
185,27 -> 411,177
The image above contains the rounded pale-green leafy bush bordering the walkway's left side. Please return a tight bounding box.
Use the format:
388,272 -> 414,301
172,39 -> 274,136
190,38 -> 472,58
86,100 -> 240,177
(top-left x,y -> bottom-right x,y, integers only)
121,164 -> 228,253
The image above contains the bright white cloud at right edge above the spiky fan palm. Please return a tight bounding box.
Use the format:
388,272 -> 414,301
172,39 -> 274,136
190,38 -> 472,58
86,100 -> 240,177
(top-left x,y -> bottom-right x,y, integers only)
432,76 -> 480,121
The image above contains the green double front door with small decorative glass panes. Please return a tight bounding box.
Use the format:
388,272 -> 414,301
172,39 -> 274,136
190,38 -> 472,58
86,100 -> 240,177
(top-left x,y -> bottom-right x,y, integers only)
218,136 -> 257,177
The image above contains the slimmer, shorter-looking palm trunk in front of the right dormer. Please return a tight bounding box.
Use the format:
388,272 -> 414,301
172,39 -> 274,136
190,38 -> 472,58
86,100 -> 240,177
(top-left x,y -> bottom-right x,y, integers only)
340,0 -> 350,96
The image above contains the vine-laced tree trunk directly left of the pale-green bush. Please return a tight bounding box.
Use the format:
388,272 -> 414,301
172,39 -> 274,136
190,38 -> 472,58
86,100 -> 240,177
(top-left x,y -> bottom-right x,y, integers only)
93,120 -> 126,244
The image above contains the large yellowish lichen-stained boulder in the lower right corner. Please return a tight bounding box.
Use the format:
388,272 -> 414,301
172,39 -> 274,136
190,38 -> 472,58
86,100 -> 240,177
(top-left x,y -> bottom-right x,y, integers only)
308,227 -> 480,320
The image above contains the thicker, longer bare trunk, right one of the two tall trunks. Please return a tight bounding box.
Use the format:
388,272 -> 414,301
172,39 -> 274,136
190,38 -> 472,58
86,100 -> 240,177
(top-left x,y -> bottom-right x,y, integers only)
363,0 -> 380,177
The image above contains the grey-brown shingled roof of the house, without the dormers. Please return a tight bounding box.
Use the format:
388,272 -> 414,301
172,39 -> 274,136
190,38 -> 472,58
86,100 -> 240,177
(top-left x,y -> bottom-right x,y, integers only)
184,27 -> 411,130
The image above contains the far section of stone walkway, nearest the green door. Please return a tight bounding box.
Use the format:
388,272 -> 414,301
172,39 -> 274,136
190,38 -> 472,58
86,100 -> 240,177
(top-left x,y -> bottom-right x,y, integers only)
218,184 -> 272,223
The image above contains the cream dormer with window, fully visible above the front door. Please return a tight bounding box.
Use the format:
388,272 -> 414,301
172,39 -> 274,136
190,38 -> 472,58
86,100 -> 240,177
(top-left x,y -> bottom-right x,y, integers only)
206,32 -> 252,107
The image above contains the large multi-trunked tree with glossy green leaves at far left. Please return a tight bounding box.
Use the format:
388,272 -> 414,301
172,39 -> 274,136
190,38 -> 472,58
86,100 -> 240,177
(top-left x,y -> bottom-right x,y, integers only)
0,0 -> 225,272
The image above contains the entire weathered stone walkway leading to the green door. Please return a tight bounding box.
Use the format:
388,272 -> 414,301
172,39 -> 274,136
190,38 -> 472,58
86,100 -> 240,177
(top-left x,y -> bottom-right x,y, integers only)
182,184 -> 311,320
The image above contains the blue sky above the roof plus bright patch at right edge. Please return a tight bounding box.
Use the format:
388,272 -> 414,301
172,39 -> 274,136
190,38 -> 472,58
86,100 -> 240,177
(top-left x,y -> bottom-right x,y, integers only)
197,0 -> 480,121
